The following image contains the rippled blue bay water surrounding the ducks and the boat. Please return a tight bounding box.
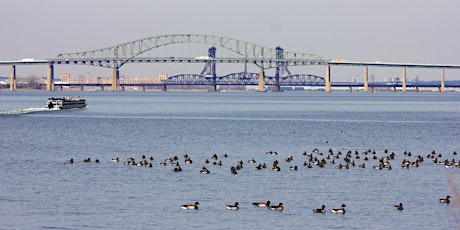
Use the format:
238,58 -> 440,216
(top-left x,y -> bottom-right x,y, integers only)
0,91 -> 460,229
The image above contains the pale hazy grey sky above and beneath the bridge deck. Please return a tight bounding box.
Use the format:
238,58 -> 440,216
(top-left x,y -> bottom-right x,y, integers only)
0,0 -> 460,81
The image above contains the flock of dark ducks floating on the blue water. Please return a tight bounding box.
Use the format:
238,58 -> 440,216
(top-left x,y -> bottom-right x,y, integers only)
67,148 -> 460,214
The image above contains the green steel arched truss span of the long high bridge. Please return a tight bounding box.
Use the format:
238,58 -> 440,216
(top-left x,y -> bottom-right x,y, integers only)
52,34 -> 328,69
